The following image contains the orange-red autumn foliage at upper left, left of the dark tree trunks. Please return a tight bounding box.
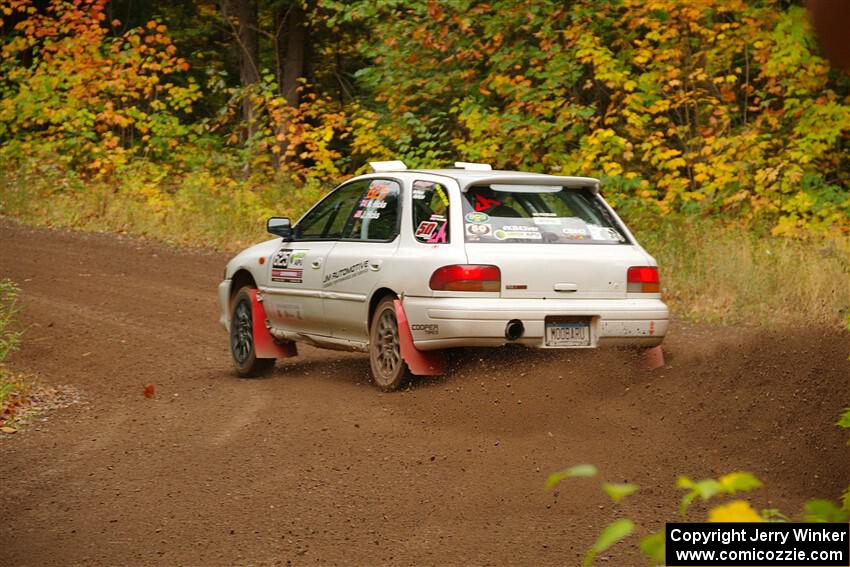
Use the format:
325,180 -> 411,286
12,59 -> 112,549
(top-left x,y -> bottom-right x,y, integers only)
0,0 -> 201,175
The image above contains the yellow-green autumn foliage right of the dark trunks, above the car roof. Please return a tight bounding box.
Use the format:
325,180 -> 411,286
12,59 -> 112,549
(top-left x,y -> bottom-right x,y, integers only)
340,0 -> 850,234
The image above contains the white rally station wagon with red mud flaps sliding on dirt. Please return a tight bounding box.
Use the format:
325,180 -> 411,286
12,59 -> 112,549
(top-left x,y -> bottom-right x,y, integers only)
219,161 -> 668,390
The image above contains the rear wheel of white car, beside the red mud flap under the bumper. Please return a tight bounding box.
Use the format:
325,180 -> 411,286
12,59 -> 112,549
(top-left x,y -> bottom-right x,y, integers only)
369,296 -> 408,391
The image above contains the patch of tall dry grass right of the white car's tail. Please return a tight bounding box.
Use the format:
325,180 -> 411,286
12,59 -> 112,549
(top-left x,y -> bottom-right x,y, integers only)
637,217 -> 850,329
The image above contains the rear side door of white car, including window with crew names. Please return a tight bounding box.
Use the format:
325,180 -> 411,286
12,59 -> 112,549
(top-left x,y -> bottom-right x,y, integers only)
322,178 -> 401,342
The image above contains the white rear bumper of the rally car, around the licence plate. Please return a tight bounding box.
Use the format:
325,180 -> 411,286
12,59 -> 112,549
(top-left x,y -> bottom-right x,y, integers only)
403,297 -> 670,350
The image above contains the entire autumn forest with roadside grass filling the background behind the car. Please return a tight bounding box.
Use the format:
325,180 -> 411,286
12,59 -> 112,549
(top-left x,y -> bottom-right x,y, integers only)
0,0 -> 850,324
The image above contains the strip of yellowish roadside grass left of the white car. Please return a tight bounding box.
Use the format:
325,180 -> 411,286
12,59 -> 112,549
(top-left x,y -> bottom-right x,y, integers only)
0,164 -> 324,251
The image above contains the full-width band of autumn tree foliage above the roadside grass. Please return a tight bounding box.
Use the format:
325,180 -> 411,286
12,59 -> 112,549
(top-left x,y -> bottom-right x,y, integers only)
0,0 -> 850,236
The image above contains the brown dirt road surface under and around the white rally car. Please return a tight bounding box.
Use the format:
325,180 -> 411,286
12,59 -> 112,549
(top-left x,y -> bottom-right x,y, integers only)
0,220 -> 850,566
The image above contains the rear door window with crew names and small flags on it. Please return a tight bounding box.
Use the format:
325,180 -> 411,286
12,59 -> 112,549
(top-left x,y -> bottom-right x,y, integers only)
344,179 -> 401,241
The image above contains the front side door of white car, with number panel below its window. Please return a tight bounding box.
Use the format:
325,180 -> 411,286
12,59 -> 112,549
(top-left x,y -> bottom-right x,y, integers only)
264,182 -> 368,336
